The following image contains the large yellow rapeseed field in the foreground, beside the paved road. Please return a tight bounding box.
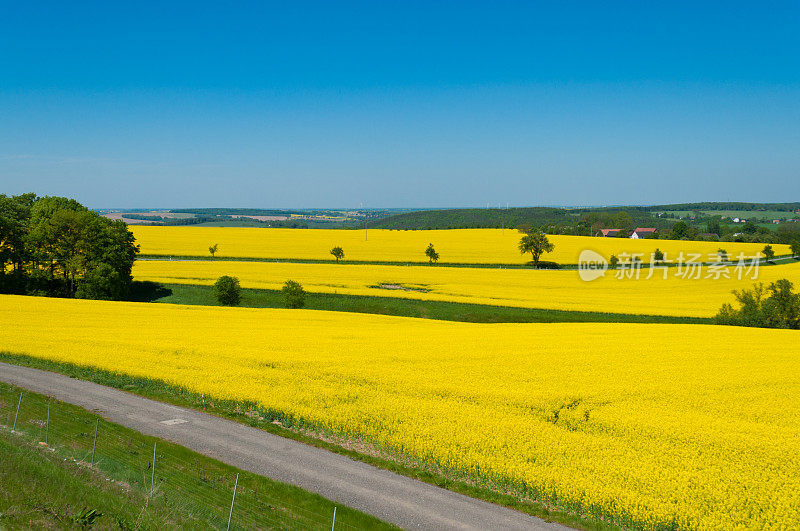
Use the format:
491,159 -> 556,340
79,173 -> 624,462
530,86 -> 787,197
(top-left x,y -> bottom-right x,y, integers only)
0,295 -> 800,529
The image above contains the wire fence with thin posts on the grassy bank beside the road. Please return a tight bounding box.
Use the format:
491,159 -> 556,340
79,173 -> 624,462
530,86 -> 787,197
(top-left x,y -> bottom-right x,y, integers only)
0,383 -> 372,530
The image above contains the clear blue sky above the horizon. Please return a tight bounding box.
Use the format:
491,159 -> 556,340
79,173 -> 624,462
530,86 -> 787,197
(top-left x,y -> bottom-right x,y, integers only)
0,0 -> 800,208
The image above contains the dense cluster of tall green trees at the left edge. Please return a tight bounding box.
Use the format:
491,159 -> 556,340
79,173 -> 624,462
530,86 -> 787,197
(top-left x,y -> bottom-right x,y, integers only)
0,193 -> 139,300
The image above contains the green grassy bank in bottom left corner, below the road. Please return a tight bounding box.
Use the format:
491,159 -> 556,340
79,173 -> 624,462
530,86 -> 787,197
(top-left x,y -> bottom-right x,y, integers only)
0,383 -> 394,529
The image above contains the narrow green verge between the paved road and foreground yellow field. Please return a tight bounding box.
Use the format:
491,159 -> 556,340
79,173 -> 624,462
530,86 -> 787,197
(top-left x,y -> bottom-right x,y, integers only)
0,352 -> 619,530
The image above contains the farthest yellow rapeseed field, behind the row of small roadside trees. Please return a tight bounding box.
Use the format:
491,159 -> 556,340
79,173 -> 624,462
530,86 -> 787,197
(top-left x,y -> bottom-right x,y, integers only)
130,225 -> 789,264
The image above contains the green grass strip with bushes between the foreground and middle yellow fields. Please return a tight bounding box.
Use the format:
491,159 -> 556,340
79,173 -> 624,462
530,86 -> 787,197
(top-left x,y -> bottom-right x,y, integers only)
135,284 -> 714,324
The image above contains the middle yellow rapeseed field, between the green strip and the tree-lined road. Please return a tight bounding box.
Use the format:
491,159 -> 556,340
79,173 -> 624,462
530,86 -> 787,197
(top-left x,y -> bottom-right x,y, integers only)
133,260 -> 800,317
